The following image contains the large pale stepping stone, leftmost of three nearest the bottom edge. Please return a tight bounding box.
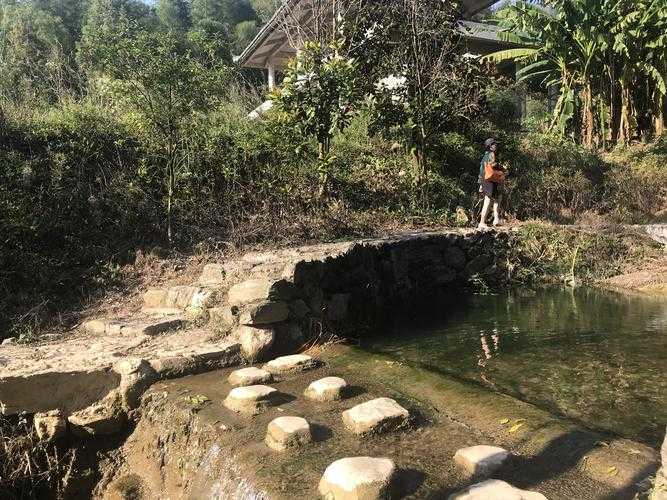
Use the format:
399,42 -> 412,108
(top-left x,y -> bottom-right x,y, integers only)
319,457 -> 396,500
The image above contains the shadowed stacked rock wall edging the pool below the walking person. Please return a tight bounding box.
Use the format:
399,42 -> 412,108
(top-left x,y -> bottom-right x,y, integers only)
215,232 -> 510,358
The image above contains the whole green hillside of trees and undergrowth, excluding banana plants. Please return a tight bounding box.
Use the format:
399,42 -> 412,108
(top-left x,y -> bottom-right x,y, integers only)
0,0 -> 667,338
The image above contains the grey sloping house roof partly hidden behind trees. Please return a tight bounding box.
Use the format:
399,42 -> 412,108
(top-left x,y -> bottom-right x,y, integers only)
235,0 -> 500,68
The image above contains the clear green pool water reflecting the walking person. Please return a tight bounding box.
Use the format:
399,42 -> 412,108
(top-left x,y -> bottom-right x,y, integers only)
362,288 -> 667,446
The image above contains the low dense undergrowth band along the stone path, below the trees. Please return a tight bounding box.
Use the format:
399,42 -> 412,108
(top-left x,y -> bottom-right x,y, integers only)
0,94 -> 667,336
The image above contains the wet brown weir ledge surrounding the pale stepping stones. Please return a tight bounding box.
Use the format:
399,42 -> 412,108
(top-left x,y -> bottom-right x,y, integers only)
96,346 -> 657,500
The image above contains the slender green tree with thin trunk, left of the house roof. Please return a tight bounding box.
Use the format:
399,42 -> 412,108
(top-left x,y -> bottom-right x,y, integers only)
100,26 -> 230,242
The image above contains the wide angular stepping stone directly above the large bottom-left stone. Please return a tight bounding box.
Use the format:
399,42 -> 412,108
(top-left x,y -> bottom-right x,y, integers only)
343,398 -> 410,435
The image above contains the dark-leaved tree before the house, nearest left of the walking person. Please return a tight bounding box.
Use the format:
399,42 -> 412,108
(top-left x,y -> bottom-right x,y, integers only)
357,0 -> 488,206
